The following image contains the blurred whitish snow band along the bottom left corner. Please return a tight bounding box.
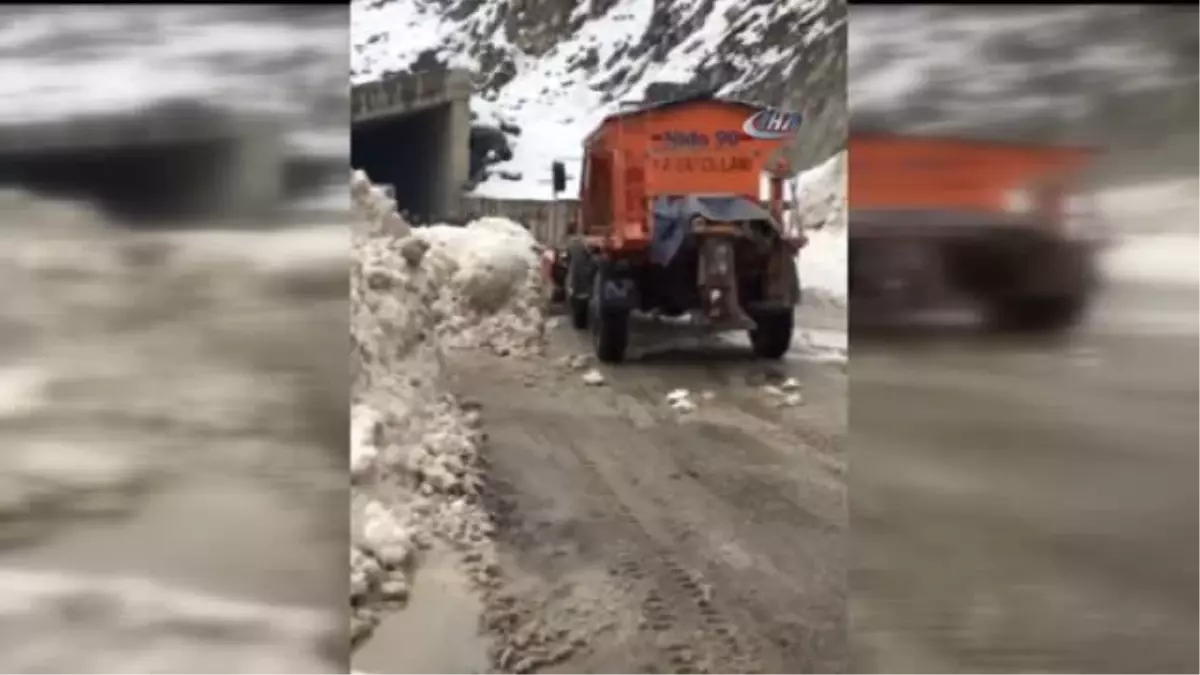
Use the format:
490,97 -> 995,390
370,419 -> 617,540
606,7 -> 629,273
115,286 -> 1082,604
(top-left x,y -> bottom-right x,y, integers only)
0,569 -> 344,675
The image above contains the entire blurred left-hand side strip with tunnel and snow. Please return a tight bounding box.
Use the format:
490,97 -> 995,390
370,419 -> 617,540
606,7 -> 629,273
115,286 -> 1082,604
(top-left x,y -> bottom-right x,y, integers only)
0,5 -> 349,674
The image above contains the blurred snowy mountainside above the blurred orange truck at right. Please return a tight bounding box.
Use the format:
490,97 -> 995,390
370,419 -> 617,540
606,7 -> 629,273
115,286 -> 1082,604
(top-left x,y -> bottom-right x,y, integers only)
848,5 -> 1200,183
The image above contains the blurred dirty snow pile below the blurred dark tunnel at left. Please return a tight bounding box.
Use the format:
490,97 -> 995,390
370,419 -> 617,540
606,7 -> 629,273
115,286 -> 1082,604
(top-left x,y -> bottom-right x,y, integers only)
0,186 -> 346,502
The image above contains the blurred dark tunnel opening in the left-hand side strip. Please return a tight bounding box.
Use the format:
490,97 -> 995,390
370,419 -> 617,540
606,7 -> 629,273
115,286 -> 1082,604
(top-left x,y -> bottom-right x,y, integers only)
0,139 -> 235,228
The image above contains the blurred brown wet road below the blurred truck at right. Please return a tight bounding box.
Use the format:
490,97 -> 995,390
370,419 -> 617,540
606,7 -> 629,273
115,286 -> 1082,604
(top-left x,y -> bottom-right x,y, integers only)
850,276 -> 1200,675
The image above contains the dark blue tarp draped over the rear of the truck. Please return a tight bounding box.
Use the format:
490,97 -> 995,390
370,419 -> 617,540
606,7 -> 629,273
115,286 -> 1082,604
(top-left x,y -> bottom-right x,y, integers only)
650,195 -> 774,265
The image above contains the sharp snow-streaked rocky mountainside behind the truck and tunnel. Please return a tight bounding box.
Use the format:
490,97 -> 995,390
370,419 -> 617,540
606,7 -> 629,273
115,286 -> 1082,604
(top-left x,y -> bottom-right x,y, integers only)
350,0 -> 847,198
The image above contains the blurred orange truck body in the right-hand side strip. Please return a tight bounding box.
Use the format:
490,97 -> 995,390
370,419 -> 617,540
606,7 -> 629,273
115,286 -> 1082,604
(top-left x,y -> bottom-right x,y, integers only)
848,133 -> 1097,214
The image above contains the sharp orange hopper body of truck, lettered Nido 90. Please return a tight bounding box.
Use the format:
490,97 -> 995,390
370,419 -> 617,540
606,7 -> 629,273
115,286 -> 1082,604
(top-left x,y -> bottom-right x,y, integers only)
577,98 -> 794,252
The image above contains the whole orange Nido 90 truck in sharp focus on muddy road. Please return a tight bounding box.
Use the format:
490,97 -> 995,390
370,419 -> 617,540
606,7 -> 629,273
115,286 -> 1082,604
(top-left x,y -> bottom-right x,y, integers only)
553,96 -> 803,363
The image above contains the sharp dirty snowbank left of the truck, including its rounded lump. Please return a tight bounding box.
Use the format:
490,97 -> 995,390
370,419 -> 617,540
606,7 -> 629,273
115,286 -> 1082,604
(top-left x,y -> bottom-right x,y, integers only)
350,172 -> 544,645
